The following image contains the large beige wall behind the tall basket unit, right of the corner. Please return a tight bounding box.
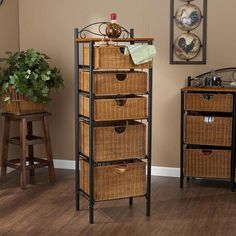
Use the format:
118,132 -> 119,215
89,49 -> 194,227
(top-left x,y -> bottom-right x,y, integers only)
17,0 -> 236,167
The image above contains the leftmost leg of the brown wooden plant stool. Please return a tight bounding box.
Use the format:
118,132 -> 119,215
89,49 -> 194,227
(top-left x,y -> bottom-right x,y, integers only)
1,116 -> 10,181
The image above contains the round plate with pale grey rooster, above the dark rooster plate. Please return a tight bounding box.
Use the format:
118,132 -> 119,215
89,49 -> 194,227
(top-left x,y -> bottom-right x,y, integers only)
175,4 -> 202,31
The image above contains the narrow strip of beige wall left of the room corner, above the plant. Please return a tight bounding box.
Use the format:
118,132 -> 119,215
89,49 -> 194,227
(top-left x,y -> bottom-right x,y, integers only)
0,0 -> 19,159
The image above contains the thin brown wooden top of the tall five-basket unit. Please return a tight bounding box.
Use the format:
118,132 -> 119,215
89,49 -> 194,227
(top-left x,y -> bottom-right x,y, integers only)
75,38 -> 153,43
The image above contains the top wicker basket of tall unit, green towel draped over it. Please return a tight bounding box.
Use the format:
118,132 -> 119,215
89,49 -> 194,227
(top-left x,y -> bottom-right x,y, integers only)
83,46 -> 152,69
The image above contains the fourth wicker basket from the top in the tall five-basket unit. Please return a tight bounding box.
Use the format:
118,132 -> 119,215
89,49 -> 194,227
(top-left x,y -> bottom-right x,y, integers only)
80,121 -> 146,161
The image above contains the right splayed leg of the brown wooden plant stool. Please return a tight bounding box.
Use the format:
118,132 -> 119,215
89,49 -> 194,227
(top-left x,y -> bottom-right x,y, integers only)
43,116 -> 56,183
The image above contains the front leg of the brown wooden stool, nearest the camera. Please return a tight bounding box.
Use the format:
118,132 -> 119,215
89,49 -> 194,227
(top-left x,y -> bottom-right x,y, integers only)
20,118 -> 26,189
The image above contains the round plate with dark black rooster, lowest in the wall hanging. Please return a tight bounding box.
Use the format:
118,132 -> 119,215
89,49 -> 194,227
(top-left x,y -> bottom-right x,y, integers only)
174,33 -> 201,60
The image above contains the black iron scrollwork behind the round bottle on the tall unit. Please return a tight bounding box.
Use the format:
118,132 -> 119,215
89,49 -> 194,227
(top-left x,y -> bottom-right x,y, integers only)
78,21 -> 131,39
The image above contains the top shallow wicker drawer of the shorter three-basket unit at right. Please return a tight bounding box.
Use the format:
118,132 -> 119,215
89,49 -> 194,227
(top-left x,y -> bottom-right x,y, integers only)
184,93 -> 233,112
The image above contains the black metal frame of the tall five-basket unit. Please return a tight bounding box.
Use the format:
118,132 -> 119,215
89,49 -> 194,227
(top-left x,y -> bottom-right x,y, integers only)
74,22 -> 152,224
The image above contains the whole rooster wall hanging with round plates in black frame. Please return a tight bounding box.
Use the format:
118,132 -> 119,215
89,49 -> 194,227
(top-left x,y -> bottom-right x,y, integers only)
170,0 -> 207,64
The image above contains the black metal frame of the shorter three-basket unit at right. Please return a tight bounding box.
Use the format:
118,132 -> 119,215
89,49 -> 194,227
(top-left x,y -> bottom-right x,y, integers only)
180,87 -> 236,192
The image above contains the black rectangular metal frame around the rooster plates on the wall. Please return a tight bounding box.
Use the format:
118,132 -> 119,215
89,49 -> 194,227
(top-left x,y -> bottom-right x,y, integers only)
170,0 -> 207,65
